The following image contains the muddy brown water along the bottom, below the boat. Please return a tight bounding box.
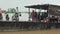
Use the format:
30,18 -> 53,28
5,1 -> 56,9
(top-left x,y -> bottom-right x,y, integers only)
0,29 -> 60,34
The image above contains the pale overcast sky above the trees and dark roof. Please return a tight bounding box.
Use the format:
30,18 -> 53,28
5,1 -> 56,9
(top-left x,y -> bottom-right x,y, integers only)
0,0 -> 60,11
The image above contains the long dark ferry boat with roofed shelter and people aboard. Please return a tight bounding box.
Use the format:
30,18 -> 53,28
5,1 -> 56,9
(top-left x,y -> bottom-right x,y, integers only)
0,4 -> 60,29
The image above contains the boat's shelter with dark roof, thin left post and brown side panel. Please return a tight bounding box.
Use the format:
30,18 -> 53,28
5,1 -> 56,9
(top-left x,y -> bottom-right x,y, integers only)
25,4 -> 60,20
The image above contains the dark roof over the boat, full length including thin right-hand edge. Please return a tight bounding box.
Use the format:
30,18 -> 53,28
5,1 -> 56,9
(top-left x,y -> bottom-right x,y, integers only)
25,4 -> 60,10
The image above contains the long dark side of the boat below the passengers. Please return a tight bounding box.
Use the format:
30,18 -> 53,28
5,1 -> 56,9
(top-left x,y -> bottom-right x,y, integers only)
0,21 -> 60,29
